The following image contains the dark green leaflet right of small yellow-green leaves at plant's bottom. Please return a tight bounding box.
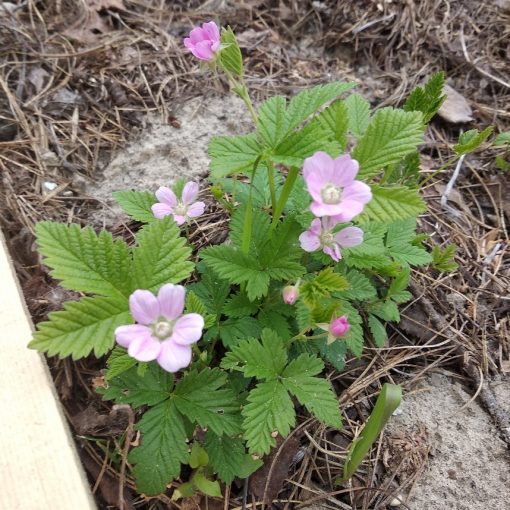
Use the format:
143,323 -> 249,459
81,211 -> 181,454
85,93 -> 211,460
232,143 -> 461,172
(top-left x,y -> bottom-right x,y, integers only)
204,431 -> 246,484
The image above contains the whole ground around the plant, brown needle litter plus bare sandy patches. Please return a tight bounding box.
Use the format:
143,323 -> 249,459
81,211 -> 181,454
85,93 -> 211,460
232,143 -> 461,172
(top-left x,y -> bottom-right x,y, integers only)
0,0 -> 510,510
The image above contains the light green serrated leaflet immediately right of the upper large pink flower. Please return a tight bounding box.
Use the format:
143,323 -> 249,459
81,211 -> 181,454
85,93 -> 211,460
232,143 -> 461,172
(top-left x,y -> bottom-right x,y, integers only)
358,184 -> 427,223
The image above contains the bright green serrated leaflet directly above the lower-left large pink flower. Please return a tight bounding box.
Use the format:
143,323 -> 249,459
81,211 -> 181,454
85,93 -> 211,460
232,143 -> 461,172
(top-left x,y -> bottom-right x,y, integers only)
133,216 -> 194,292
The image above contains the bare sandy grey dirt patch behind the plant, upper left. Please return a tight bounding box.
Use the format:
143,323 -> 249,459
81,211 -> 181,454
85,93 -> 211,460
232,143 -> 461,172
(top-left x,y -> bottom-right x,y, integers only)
85,95 -> 250,226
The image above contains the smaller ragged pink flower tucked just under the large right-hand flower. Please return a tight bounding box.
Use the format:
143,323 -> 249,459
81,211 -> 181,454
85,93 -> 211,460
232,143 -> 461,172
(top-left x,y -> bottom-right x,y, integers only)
299,217 -> 363,262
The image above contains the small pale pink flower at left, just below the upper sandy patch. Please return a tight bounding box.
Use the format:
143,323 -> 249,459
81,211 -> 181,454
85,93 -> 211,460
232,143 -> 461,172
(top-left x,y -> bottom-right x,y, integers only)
152,182 -> 205,225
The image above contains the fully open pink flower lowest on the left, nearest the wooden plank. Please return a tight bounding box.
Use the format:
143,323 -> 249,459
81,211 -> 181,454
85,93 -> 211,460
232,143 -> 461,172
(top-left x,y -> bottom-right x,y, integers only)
115,283 -> 204,372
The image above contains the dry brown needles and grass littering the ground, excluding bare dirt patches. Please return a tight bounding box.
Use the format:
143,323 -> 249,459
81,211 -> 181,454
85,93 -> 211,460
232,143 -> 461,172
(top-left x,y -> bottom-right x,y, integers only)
0,0 -> 510,510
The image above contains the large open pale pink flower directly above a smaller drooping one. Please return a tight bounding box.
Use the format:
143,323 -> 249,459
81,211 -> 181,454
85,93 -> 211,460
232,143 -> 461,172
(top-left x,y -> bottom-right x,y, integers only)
303,151 -> 372,222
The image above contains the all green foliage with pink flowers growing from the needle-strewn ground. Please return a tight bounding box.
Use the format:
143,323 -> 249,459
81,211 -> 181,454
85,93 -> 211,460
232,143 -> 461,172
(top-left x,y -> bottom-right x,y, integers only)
26,22 -> 488,497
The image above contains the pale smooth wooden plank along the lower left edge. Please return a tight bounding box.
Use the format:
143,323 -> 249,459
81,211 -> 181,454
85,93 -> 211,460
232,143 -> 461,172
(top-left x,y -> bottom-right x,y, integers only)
0,232 -> 96,510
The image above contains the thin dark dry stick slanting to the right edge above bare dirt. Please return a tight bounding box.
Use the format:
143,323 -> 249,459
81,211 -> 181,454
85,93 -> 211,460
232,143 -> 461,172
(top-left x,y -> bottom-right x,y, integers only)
411,283 -> 510,447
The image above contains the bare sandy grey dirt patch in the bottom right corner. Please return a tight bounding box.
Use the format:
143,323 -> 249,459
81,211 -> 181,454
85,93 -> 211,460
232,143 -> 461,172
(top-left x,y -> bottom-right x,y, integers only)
386,374 -> 510,510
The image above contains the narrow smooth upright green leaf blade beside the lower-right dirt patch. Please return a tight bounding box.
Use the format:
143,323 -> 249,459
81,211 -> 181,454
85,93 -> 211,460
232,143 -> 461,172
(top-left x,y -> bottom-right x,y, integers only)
335,383 -> 402,484
